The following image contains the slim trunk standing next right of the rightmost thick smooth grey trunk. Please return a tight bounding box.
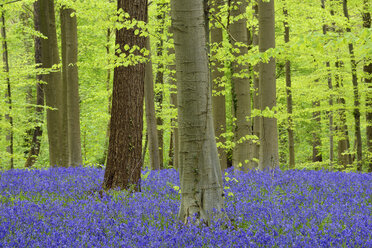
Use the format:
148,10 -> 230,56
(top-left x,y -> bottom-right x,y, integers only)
283,4 -> 295,169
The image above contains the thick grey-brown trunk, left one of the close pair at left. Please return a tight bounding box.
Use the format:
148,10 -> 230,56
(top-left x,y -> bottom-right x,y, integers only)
39,0 -> 63,166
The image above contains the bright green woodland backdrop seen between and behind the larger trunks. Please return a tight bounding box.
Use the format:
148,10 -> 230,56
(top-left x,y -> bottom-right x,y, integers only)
0,0 -> 372,171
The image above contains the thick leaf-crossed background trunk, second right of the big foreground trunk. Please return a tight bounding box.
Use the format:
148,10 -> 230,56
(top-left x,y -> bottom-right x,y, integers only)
230,0 -> 254,170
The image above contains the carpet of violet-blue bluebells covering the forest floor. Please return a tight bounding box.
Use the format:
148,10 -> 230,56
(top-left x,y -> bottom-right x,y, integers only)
0,167 -> 372,247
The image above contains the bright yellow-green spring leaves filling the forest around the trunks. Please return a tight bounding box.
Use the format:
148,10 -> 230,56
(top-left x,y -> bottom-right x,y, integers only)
0,0 -> 372,170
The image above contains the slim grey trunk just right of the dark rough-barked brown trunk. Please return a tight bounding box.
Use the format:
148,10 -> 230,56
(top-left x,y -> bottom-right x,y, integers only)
145,37 -> 160,170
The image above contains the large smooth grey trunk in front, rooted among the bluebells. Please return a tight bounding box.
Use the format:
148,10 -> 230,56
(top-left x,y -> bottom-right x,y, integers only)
171,0 -> 223,223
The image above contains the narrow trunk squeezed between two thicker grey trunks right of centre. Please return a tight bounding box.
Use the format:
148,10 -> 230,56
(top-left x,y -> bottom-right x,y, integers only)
252,3 -> 261,168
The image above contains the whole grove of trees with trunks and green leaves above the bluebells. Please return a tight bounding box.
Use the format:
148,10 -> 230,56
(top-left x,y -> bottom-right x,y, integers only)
0,0 -> 372,219
